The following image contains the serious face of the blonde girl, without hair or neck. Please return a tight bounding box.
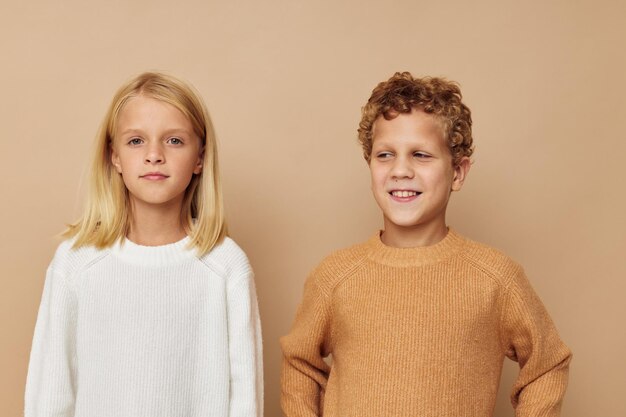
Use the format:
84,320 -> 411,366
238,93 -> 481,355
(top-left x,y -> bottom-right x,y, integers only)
111,95 -> 203,214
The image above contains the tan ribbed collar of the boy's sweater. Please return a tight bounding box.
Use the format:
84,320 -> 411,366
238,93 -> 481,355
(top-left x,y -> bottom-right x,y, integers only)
366,229 -> 465,267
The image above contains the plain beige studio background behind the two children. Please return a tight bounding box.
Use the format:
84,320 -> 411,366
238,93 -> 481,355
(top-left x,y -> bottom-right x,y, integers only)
0,0 -> 626,417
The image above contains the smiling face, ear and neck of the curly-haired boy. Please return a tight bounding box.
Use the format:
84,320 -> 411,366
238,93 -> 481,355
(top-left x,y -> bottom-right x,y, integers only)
369,109 -> 469,246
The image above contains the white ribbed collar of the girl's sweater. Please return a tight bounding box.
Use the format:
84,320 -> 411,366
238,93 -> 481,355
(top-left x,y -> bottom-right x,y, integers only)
111,236 -> 196,267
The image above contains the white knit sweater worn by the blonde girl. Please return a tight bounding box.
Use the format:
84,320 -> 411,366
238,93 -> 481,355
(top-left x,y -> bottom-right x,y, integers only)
25,238 -> 263,417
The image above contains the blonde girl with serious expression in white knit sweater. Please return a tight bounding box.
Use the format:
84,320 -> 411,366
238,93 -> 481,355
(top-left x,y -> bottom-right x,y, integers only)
25,73 -> 263,417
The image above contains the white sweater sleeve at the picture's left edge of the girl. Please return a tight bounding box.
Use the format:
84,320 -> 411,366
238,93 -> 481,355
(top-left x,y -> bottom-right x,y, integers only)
24,267 -> 76,417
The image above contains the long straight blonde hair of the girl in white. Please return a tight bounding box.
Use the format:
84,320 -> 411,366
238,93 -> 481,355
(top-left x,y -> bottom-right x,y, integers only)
63,72 -> 226,255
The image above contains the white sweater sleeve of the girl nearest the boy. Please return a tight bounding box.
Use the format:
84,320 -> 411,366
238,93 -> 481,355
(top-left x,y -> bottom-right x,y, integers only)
228,270 -> 263,417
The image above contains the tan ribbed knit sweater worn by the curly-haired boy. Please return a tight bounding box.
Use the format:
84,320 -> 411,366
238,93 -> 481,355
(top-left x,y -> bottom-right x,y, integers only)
281,230 -> 571,417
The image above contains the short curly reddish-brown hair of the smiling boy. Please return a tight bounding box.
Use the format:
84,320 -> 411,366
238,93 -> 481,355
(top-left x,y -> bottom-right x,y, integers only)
358,72 -> 474,165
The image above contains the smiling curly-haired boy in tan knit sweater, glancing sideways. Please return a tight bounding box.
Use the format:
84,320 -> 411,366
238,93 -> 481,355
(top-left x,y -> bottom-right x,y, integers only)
281,72 -> 571,417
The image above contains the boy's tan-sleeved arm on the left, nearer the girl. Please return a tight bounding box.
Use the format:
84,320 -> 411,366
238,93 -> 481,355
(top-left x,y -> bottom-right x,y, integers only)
280,276 -> 330,417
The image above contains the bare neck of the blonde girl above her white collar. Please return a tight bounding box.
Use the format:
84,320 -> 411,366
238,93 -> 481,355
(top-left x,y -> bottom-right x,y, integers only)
126,197 -> 187,246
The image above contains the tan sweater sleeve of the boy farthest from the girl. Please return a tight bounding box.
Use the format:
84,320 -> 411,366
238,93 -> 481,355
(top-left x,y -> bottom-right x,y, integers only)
502,269 -> 572,417
